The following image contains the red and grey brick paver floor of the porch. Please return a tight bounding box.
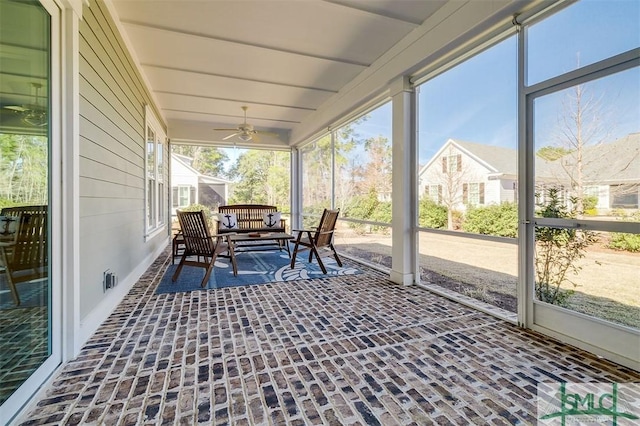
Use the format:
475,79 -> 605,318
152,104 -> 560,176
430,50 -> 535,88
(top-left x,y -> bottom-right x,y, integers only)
15,251 -> 640,426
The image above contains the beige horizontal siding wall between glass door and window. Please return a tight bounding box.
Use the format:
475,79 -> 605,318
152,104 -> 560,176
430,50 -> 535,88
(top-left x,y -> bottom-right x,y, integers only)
80,1 -> 168,318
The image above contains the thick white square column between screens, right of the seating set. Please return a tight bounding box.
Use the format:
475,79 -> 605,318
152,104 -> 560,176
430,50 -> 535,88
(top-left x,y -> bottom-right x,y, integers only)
390,77 -> 416,285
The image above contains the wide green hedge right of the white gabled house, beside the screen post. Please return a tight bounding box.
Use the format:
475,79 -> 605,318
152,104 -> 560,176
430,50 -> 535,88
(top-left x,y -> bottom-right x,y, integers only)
462,203 -> 518,238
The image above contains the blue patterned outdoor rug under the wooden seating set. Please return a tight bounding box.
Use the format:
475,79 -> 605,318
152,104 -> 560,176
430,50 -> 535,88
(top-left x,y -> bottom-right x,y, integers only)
156,249 -> 361,294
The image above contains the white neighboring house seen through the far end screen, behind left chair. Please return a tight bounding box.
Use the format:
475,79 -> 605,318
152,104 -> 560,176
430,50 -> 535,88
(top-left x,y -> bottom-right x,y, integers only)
171,154 -> 229,216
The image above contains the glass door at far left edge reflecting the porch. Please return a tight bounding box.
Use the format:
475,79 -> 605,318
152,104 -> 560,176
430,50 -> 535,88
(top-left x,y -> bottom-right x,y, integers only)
0,0 -> 60,423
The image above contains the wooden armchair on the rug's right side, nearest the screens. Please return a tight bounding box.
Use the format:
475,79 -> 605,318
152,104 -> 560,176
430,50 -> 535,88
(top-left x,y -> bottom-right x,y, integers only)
291,209 -> 342,274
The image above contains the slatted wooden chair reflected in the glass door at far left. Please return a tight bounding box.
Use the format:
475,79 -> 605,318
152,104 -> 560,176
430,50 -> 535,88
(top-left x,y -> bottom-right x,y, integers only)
0,206 -> 49,306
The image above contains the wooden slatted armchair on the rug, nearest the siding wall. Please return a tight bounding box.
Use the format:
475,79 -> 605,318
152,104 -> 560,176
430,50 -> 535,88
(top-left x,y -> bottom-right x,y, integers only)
172,211 -> 238,287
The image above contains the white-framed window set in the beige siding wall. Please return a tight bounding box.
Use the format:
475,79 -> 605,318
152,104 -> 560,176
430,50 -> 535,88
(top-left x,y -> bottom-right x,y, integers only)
145,106 -> 167,235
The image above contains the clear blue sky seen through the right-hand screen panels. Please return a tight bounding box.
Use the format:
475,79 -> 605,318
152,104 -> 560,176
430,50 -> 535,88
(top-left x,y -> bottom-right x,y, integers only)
359,0 -> 640,164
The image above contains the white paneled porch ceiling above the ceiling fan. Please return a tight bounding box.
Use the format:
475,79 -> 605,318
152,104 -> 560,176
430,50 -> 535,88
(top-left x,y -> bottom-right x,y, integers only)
112,0 -> 446,144
